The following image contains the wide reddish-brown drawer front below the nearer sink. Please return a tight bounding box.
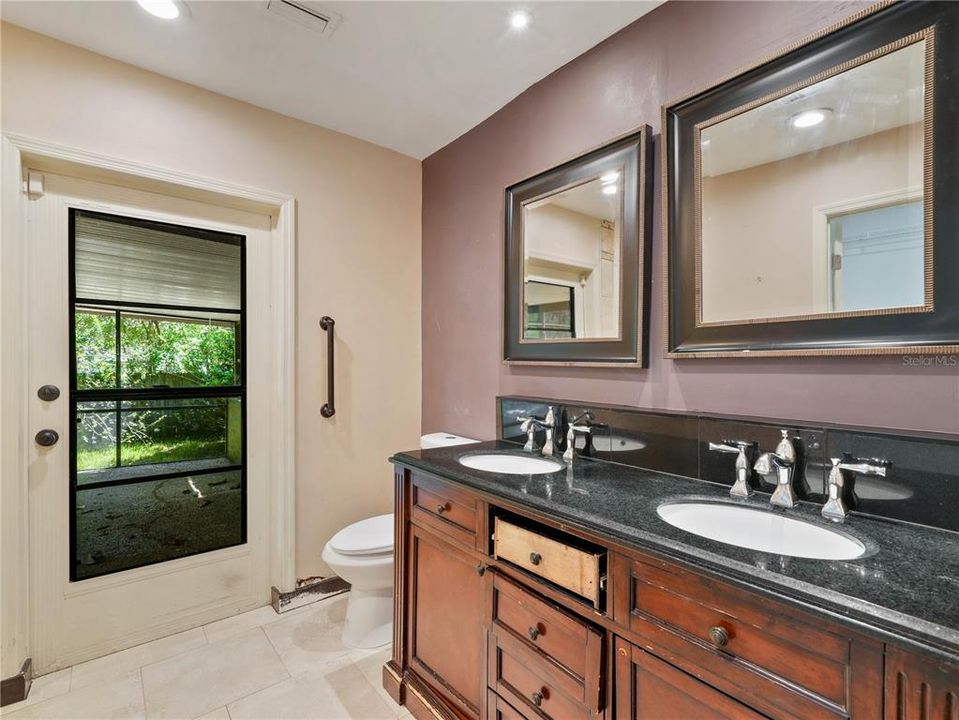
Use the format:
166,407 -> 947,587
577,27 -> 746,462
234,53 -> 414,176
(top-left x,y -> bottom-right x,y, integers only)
614,559 -> 881,718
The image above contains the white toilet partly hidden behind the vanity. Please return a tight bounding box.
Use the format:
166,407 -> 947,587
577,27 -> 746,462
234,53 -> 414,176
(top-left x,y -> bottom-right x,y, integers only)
323,433 -> 479,648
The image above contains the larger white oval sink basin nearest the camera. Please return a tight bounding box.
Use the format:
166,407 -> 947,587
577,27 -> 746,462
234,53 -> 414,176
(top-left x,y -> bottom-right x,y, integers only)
656,502 -> 866,560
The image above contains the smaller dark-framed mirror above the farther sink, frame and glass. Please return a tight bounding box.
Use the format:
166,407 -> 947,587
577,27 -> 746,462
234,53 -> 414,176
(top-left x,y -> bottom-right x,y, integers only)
504,126 -> 652,367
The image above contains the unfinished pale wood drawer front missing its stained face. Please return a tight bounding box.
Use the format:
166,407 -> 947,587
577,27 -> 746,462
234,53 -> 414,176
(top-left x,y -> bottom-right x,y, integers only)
493,517 -> 605,607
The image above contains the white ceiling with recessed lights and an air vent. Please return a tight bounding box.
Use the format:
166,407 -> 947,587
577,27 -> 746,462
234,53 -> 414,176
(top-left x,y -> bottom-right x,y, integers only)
0,0 -> 665,158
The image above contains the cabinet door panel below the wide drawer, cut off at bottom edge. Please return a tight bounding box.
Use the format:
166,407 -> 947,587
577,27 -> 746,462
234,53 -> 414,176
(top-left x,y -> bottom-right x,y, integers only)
615,638 -> 765,720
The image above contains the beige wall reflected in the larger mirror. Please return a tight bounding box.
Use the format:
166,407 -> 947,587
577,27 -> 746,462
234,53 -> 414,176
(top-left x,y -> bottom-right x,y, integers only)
703,123 -> 922,322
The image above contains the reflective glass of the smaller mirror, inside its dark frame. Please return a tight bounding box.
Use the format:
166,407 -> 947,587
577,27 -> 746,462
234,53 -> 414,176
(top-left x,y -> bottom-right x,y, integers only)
523,174 -> 623,342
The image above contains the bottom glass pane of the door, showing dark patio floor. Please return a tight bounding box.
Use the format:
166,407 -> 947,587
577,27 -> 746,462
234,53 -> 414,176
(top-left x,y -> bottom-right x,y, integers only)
75,470 -> 244,580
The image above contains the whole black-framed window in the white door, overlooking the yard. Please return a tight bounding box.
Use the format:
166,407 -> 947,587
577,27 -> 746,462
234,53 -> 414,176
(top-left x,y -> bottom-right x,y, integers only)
70,210 -> 246,581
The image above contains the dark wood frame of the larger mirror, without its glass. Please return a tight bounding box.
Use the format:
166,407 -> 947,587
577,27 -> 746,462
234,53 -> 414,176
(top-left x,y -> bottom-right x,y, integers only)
662,2 -> 959,358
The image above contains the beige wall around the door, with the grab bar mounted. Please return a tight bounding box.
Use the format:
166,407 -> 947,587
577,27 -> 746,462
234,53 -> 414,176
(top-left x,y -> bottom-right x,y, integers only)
0,24 -> 421,578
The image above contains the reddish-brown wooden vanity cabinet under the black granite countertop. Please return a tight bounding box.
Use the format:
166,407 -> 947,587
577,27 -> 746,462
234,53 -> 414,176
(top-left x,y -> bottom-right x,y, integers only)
384,468 -> 959,720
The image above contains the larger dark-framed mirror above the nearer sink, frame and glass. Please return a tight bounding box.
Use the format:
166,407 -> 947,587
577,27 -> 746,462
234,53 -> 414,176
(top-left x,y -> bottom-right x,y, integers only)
663,3 -> 959,357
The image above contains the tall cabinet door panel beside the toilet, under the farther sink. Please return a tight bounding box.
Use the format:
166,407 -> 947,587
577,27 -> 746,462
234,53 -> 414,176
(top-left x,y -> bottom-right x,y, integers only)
407,526 -> 485,718
